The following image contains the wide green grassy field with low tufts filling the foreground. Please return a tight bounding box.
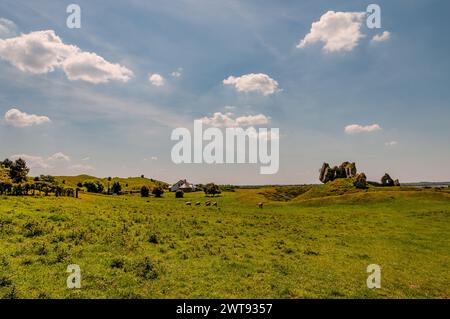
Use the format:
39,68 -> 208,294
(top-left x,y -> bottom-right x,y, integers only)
0,185 -> 450,298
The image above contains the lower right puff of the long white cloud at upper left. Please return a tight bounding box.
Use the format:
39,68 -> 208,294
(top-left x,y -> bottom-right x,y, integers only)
63,52 -> 133,84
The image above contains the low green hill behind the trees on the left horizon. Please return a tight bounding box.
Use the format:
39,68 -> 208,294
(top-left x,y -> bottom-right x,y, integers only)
55,174 -> 167,191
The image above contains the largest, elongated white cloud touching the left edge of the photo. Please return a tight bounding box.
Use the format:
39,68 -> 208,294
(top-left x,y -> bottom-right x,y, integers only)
0,30 -> 133,84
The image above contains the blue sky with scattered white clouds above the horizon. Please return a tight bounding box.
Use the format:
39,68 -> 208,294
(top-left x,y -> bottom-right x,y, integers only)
0,0 -> 450,184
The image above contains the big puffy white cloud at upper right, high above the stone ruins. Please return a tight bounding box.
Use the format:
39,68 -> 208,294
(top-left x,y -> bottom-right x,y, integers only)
297,11 -> 366,52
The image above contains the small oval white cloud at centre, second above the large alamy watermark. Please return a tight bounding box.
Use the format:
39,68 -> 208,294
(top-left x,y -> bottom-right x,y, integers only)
223,73 -> 279,96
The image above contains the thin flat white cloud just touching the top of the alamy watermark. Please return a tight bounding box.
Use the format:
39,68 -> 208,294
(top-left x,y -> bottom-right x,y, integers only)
201,112 -> 269,127
